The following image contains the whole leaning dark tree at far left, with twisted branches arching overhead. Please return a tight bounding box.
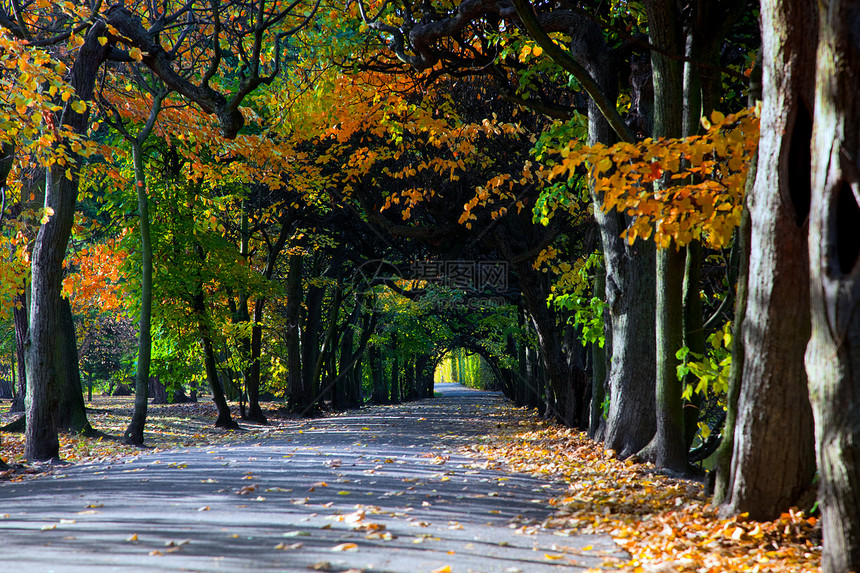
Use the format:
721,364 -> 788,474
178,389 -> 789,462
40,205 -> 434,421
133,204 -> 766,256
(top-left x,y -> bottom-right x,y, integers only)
0,1 -> 317,459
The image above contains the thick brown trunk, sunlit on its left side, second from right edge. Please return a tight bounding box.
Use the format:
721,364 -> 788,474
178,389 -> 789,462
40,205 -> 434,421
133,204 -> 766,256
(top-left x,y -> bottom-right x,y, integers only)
718,0 -> 816,520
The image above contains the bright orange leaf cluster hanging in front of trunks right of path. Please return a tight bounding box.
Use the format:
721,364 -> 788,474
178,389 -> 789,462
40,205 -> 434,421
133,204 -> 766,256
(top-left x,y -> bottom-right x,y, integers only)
550,110 -> 759,248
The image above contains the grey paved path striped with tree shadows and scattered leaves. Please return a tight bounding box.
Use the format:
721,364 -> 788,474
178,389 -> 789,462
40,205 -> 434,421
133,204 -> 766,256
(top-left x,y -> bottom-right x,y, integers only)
0,384 -> 618,573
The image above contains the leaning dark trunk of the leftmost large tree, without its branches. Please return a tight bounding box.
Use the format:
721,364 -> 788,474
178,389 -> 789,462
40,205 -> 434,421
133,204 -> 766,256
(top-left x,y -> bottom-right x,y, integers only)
24,20 -> 110,460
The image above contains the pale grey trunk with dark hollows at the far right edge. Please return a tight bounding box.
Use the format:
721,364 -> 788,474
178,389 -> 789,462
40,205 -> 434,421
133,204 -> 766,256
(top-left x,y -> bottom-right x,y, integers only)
808,0 -> 860,573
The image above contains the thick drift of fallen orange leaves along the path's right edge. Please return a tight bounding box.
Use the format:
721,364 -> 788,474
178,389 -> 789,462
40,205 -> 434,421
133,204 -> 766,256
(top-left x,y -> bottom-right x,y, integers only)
470,409 -> 821,573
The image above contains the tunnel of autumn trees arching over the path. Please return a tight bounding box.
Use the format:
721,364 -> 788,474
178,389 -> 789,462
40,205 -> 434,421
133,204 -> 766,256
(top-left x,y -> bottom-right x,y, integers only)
0,0 -> 860,571
